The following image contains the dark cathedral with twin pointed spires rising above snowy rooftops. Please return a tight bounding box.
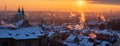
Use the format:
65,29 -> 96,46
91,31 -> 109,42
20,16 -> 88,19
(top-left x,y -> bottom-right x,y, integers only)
13,7 -> 31,27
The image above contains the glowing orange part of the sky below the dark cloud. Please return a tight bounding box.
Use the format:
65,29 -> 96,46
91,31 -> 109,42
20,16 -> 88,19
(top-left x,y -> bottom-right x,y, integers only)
0,0 -> 120,11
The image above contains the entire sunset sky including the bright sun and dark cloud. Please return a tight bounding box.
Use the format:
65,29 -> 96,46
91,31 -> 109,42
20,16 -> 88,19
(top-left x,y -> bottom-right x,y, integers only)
0,0 -> 120,11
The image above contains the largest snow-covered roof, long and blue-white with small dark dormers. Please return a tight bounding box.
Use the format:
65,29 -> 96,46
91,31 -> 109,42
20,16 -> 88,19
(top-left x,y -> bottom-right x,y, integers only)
0,26 -> 44,40
